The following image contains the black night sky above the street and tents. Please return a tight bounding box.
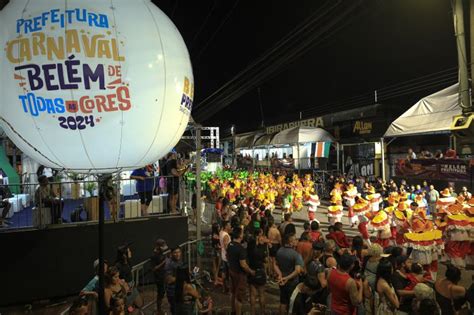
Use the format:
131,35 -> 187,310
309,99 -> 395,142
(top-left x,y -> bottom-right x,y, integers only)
154,0 -> 457,132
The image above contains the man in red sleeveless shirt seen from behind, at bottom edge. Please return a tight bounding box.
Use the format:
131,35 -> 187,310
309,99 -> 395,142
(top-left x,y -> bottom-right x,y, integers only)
328,253 -> 363,315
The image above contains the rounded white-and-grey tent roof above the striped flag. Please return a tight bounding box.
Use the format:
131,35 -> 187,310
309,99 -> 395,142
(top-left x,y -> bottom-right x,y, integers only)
271,126 -> 334,145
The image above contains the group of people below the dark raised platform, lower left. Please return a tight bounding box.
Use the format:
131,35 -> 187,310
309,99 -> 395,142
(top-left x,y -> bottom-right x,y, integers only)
69,239 -> 213,315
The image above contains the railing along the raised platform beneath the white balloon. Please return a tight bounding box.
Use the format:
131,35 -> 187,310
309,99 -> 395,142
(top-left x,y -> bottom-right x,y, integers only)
0,176 -> 184,231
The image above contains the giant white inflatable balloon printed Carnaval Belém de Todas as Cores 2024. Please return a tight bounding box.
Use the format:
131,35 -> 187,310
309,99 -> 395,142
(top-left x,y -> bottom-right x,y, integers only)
0,0 -> 194,172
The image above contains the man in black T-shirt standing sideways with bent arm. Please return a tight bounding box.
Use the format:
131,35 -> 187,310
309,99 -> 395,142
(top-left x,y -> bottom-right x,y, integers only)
227,227 -> 255,315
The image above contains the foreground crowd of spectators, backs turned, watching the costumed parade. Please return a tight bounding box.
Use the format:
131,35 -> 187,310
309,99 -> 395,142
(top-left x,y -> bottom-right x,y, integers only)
212,195 -> 474,315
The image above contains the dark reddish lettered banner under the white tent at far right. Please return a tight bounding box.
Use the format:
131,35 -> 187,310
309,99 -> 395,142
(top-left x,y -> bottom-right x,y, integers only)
395,159 -> 472,181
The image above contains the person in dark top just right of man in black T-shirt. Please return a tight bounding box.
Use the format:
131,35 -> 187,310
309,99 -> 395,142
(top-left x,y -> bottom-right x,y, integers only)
247,229 -> 268,315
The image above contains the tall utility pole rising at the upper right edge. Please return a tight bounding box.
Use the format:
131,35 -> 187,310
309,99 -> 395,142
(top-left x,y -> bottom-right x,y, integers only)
453,0 -> 472,114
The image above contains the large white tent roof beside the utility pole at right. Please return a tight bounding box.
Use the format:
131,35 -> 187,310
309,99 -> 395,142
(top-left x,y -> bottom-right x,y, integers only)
384,84 -> 461,137
